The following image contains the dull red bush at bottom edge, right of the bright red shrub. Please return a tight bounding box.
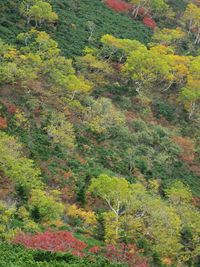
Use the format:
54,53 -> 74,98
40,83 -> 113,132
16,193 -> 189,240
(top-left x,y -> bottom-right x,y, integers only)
105,244 -> 149,267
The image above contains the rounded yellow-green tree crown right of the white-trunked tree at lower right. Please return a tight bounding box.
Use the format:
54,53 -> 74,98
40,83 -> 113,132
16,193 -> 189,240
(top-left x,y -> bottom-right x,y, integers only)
144,198 -> 183,261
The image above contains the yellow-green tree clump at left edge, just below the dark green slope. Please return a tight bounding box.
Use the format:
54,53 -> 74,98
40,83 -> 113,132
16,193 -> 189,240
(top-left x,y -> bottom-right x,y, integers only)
0,29 -> 92,100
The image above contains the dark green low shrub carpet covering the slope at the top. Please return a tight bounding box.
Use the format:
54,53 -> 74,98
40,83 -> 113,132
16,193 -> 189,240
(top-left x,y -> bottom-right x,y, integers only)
0,0 -> 152,57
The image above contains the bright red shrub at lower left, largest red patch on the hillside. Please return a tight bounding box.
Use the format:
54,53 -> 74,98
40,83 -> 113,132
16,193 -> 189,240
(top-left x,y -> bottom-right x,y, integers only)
13,231 -> 87,257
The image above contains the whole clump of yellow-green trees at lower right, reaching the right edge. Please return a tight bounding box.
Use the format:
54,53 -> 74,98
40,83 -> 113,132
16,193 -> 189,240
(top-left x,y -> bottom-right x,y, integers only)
89,175 -> 199,264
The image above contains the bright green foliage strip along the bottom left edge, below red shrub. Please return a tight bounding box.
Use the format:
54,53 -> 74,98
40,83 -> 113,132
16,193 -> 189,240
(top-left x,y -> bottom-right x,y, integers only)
0,243 -> 127,267
